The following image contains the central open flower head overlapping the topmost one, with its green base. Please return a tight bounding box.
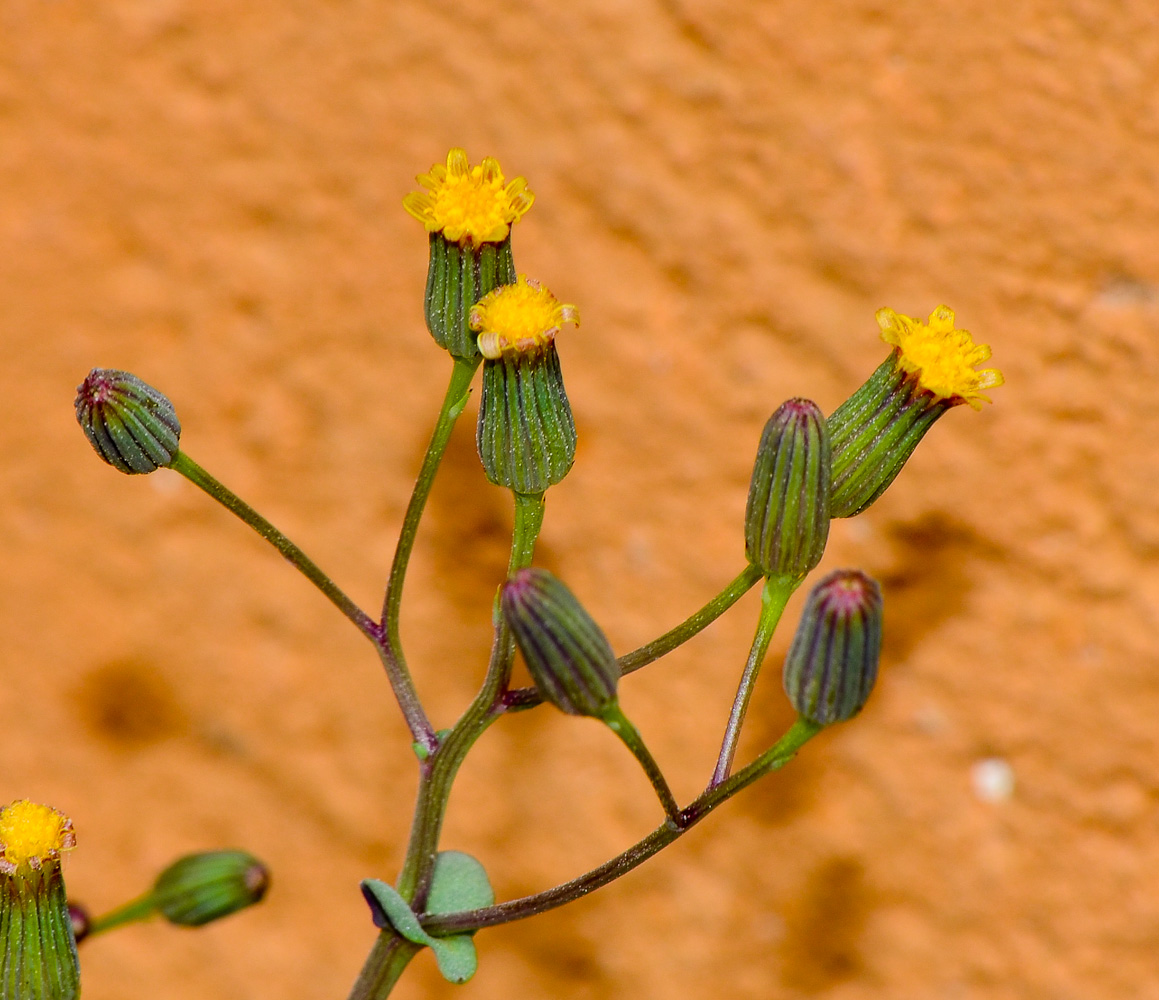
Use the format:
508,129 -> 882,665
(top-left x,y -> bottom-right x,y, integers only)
471,275 -> 580,494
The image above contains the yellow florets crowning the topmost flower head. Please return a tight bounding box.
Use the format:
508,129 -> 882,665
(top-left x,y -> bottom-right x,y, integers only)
402,148 -> 535,246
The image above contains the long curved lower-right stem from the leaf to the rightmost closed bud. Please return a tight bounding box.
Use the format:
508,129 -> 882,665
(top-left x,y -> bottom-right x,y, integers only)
421,718 -> 821,935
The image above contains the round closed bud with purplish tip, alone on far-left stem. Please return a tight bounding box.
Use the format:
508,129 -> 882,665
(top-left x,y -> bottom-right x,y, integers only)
76,368 -> 181,475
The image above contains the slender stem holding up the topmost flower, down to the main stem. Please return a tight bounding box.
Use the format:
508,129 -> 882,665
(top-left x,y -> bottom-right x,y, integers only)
379,358 -> 481,753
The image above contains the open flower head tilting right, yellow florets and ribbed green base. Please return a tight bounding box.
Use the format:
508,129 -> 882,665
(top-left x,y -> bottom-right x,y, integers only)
829,306 -> 1003,517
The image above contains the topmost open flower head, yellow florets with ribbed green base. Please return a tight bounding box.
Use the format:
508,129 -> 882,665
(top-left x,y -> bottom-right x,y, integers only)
402,149 -> 534,358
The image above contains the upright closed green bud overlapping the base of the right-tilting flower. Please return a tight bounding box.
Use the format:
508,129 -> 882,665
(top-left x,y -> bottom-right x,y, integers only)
744,399 -> 830,579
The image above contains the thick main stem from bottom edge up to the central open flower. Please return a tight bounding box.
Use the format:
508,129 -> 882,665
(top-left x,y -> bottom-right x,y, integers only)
349,486 -> 544,1000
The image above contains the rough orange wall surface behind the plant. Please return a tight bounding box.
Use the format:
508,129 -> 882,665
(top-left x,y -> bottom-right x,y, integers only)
0,0 -> 1159,1000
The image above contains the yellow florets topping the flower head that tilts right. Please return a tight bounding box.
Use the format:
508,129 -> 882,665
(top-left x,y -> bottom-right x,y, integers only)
877,306 -> 1005,410
